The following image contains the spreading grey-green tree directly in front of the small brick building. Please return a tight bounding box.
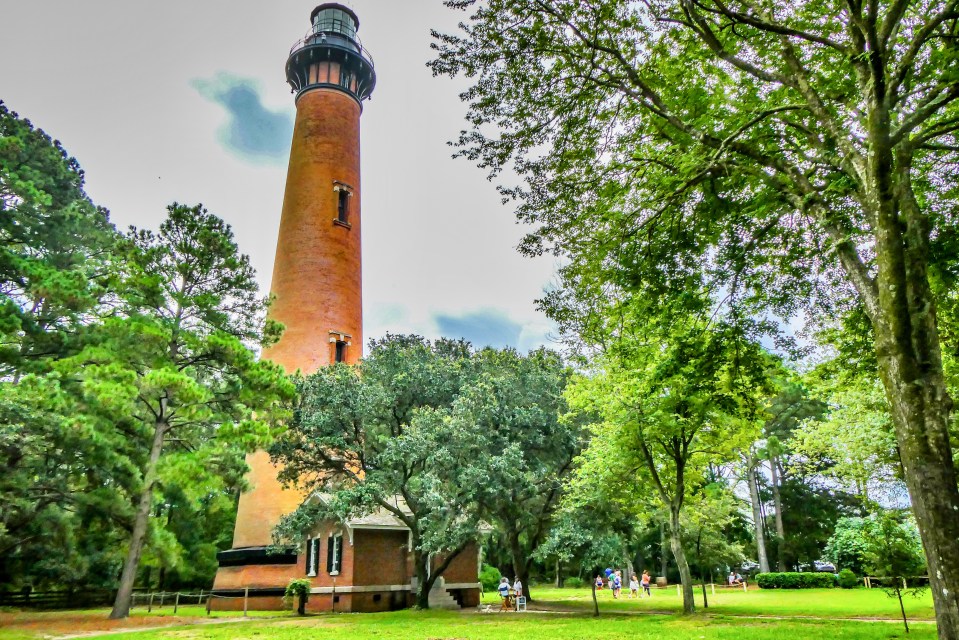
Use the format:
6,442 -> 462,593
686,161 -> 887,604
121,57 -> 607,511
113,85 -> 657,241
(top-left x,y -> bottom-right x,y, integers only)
270,335 -> 480,609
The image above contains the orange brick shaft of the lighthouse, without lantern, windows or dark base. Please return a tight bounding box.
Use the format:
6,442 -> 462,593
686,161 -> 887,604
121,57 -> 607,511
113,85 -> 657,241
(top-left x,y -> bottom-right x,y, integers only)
233,88 -> 363,548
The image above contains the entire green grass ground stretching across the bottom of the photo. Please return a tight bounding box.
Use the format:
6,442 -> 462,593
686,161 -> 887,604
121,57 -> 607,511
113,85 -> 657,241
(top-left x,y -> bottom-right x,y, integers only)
0,588 -> 935,640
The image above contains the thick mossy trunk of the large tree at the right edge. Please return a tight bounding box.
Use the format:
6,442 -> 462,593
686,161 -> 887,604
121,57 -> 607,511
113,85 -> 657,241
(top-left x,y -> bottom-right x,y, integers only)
867,151 -> 959,640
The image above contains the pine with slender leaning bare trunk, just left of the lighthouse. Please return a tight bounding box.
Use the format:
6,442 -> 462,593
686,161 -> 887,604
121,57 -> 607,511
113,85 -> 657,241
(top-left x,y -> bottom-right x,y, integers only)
58,204 -> 292,618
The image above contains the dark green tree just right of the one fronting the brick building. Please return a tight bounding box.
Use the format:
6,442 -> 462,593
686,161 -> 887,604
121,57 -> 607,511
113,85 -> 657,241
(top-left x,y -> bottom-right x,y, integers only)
451,349 -> 581,597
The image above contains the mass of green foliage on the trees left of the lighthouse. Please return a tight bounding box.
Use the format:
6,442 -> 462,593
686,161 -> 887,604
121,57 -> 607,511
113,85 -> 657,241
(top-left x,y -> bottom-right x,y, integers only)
0,104 -> 293,588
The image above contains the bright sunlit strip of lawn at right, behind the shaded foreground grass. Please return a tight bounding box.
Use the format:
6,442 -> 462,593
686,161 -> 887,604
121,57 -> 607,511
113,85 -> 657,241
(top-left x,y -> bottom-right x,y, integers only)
516,587 -> 935,620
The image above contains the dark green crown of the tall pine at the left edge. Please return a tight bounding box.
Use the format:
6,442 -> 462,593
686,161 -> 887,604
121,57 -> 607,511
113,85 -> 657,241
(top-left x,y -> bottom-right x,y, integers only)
0,102 -> 117,381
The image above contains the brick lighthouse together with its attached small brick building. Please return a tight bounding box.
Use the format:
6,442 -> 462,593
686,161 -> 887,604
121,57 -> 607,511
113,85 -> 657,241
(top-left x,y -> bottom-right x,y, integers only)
212,3 -> 479,611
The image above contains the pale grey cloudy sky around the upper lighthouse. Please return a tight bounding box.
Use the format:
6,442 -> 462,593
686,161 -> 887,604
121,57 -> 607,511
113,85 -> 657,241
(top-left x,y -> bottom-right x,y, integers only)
0,0 -> 555,351
